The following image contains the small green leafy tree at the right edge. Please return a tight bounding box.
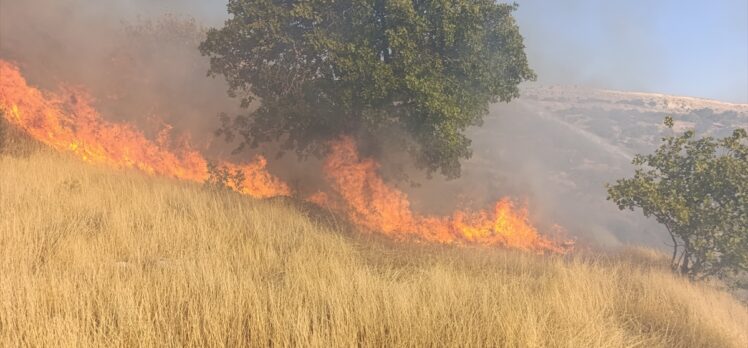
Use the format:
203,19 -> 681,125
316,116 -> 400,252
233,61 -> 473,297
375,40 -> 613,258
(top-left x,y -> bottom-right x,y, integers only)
608,117 -> 748,279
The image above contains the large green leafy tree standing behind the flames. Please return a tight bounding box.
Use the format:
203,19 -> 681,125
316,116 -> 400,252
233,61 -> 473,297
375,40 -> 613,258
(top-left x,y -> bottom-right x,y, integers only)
200,0 -> 534,177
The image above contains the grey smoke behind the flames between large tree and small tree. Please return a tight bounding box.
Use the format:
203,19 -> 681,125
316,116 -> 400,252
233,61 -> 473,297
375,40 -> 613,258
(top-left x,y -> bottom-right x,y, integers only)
400,98 -> 667,247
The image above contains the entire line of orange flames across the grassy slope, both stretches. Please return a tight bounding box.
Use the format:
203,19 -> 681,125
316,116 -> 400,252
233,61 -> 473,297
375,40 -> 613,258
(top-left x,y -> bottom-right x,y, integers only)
0,60 -> 568,253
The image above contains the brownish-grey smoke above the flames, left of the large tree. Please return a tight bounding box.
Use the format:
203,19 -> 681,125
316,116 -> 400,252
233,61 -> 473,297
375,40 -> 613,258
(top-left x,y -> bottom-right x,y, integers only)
0,0 -> 237,152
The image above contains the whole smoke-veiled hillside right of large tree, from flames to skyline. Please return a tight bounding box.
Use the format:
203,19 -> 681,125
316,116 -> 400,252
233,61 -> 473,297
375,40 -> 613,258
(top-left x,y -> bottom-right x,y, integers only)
411,85 -> 748,248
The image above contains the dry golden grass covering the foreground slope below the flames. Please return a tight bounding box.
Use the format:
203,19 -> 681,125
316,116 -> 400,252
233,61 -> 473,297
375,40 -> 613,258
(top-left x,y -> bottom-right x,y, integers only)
0,151 -> 748,347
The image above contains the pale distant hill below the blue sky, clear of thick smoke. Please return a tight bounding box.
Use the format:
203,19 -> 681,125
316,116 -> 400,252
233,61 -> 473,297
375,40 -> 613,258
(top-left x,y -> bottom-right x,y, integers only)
520,86 -> 748,154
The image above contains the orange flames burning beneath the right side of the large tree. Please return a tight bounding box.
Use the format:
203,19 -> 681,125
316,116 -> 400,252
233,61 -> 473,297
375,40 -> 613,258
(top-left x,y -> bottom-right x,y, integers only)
313,137 -> 570,253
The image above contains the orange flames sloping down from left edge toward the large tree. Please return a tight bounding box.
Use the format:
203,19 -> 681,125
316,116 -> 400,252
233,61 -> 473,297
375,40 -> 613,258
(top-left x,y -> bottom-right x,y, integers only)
0,60 -> 291,198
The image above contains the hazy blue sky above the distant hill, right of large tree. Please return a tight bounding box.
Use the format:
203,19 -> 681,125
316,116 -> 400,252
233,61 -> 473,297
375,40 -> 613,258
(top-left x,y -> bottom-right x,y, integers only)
515,0 -> 748,103
